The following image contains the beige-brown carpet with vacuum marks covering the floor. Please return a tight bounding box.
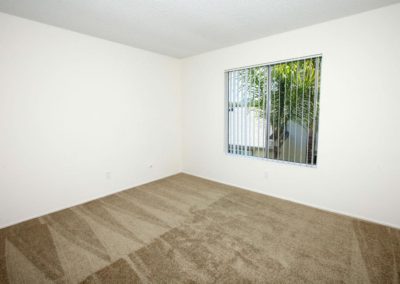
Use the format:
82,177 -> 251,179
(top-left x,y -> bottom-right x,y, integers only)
0,174 -> 400,283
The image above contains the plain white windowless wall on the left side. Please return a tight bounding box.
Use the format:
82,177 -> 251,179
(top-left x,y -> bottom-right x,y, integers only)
0,13 -> 181,227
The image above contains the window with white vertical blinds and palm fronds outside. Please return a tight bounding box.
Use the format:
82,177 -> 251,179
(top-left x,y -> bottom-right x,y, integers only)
226,56 -> 322,165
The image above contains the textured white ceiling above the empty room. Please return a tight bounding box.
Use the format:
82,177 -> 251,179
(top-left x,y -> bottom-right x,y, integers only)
0,0 -> 400,58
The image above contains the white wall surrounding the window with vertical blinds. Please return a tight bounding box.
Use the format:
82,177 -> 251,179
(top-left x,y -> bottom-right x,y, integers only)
182,4 -> 400,227
